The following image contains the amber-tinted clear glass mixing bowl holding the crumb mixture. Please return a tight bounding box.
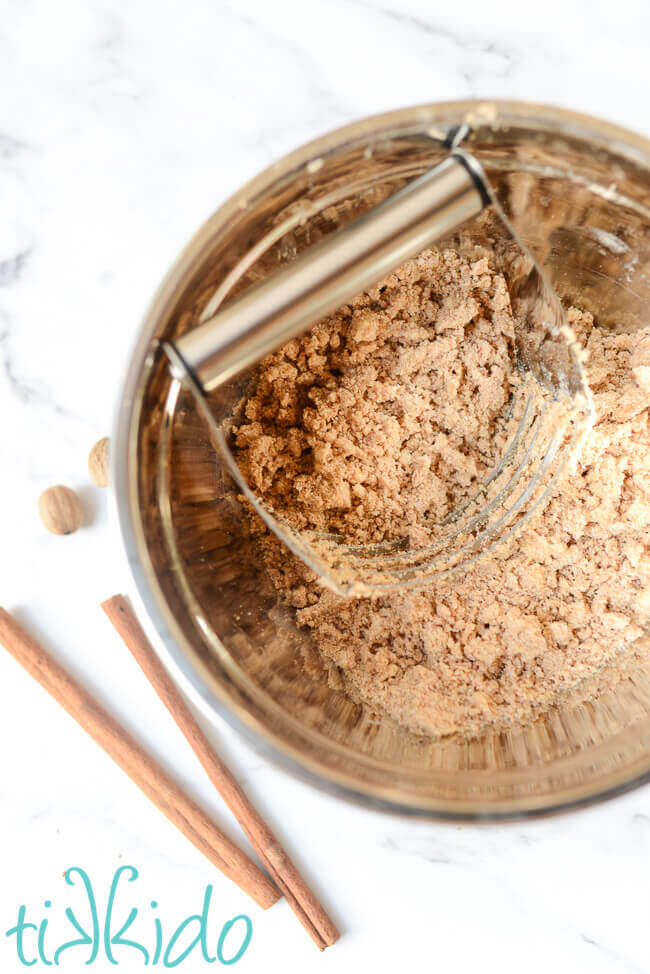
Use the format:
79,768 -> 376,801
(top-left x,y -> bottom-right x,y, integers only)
112,102 -> 650,819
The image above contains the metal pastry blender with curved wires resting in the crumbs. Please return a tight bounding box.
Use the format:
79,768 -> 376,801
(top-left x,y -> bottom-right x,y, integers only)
163,148 -> 592,595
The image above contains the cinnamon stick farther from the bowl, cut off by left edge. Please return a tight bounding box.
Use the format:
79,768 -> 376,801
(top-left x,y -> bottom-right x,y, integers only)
0,608 -> 279,910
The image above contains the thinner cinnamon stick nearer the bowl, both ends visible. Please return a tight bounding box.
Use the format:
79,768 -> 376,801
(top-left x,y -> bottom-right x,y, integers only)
102,595 -> 339,950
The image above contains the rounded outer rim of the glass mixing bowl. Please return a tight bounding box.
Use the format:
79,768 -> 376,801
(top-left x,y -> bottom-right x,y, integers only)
110,99 -> 650,822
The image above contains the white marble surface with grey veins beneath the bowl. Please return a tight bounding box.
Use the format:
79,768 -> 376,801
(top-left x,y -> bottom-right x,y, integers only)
0,0 -> 650,974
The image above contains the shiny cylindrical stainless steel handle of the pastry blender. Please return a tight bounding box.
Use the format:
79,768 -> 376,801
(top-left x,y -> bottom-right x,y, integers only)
176,155 -> 490,391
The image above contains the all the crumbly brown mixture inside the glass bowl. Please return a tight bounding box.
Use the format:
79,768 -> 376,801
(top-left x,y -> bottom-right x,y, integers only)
236,252 -> 650,737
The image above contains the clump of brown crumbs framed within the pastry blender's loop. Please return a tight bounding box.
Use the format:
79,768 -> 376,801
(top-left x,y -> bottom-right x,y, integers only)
235,250 -> 519,542
